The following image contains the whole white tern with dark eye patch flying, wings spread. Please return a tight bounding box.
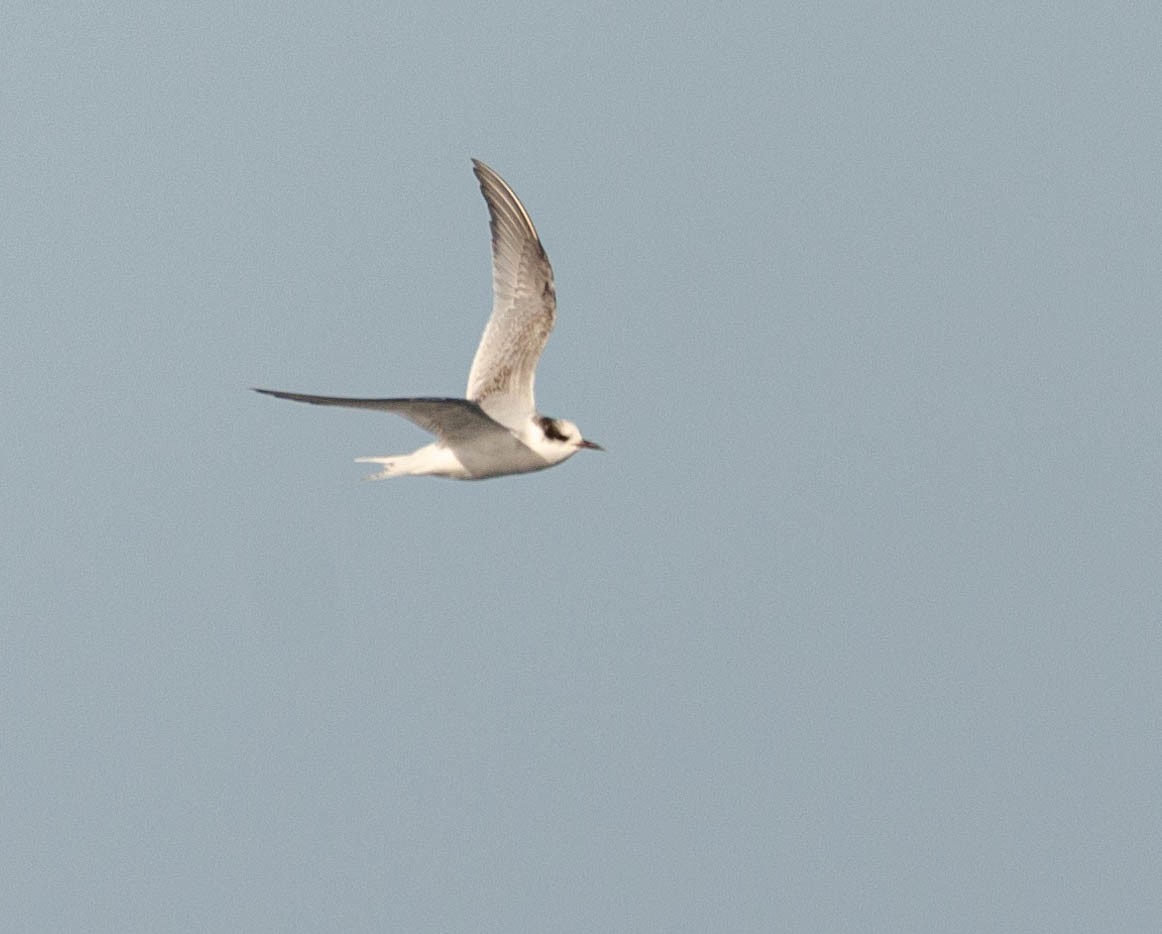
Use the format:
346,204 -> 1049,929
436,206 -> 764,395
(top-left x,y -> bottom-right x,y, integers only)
254,159 -> 604,480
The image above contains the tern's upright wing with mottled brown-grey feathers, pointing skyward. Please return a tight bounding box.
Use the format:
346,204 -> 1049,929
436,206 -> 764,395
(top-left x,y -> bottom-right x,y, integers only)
466,159 -> 557,426
